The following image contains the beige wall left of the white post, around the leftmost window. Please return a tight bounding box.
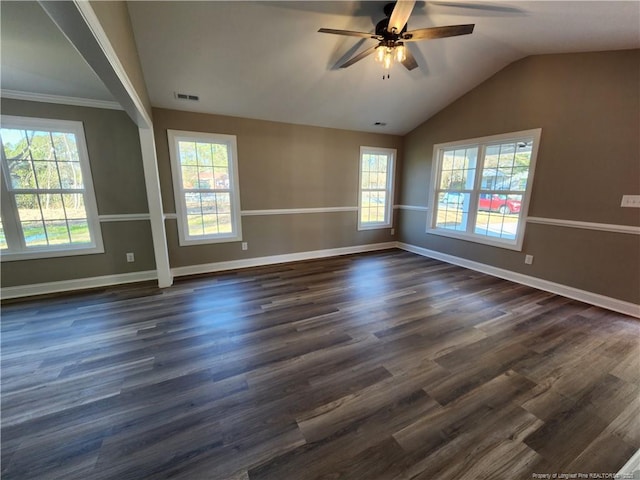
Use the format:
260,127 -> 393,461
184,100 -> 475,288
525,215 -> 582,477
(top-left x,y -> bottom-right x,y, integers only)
0,98 -> 155,287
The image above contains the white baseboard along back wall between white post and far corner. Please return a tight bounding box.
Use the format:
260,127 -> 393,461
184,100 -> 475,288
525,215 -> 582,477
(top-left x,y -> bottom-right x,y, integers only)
171,242 -> 397,277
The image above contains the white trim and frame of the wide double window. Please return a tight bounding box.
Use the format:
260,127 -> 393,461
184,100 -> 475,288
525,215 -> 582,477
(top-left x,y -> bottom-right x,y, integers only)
426,128 -> 542,251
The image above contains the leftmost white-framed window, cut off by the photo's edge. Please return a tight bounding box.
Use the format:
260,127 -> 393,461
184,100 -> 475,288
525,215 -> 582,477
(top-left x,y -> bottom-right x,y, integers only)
0,115 -> 104,260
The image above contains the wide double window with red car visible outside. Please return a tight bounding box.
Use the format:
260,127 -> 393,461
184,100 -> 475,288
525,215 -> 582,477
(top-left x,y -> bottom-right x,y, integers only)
427,129 -> 541,250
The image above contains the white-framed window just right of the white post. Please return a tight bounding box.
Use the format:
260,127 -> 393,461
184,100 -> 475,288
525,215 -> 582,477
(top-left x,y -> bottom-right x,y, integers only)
167,130 -> 242,245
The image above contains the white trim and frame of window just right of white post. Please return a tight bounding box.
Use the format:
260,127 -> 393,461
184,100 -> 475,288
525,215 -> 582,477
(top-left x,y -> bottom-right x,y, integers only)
167,130 -> 242,246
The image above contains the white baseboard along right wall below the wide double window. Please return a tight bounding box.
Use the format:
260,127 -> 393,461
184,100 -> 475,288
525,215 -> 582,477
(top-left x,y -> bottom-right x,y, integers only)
396,242 -> 640,318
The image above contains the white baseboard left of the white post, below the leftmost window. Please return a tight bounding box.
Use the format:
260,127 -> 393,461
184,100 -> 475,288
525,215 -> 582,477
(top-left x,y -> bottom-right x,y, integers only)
0,270 -> 158,300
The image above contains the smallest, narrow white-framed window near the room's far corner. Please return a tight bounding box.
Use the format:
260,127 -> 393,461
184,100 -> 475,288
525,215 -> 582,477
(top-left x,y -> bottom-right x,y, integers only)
358,147 -> 396,230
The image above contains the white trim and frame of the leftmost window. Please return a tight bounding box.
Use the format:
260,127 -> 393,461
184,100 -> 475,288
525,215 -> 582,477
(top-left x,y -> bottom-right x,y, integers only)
0,115 -> 104,262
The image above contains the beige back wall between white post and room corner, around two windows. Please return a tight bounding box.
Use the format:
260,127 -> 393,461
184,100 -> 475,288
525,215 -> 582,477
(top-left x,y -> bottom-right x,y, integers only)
153,108 -> 402,267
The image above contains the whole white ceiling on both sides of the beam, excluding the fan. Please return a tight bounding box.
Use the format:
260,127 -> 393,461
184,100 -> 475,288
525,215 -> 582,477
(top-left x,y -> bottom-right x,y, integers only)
1,0 -> 640,134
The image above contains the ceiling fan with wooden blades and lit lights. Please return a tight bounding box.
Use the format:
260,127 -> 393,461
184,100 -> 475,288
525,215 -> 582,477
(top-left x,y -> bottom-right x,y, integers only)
318,0 -> 475,79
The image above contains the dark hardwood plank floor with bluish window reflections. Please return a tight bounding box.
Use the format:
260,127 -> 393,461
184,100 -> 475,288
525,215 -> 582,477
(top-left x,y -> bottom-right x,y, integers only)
1,250 -> 640,480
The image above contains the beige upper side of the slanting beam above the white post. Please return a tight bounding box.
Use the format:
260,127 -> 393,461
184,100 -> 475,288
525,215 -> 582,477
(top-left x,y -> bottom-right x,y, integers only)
91,1 -> 151,116
